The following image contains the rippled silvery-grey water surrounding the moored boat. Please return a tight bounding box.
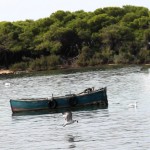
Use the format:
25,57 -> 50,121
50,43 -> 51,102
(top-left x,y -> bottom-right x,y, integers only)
0,67 -> 150,150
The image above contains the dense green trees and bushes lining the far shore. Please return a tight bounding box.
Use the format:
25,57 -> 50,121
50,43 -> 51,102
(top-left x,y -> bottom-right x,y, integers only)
0,5 -> 150,70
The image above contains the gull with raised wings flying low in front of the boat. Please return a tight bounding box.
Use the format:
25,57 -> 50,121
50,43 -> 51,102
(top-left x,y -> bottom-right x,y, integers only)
63,111 -> 78,127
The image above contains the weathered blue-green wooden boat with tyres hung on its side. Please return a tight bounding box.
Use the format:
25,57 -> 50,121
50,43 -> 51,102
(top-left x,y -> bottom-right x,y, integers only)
10,87 -> 108,113
